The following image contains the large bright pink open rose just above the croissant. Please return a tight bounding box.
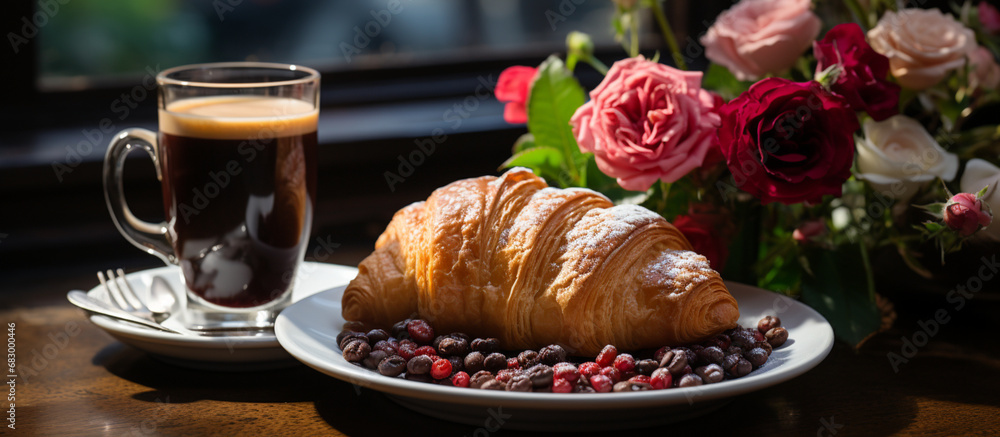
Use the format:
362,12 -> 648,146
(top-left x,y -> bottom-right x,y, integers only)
570,56 -> 719,191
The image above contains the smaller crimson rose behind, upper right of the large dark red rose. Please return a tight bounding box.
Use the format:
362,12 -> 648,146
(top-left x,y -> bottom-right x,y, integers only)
813,23 -> 899,121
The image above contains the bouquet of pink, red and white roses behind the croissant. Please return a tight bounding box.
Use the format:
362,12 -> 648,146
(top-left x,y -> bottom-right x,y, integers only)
496,0 -> 1000,345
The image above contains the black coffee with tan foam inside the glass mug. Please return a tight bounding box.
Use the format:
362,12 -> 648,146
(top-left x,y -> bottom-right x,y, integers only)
159,97 -> 317,308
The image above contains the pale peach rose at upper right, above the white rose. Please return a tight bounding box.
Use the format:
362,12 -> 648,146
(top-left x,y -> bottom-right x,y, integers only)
868,9 -> 976,90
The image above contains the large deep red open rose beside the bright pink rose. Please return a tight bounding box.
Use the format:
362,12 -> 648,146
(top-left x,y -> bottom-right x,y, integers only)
716,78 -> 858,204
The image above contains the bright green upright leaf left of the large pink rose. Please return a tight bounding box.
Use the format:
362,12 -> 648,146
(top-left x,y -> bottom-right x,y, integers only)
527,55 -> 586,186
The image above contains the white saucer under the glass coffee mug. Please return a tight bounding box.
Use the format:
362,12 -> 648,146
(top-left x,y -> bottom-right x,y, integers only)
87,262 -> 358,370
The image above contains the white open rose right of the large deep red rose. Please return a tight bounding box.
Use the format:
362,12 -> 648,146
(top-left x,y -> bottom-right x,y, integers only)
857,115 -> 960,204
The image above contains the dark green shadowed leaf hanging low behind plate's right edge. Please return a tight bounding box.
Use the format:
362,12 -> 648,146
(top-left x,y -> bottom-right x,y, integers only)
802,245 -> 882,347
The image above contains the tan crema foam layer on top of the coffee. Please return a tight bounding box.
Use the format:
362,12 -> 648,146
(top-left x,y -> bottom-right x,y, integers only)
159,96 -> 319,140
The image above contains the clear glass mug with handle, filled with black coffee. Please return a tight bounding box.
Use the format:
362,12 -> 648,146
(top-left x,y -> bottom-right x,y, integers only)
104,62 -> 319,330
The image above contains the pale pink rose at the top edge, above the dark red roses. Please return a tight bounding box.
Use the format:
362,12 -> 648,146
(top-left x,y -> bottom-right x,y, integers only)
701,0 -> 821,80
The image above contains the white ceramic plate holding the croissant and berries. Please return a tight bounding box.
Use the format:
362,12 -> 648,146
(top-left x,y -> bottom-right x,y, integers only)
275,283 -> 833,431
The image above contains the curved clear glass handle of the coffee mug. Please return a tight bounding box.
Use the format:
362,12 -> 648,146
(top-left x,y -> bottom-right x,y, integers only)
104,129 -> 177,264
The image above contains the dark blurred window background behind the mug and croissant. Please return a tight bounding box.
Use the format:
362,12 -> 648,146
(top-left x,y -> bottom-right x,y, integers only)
0,0 -> 744,299
